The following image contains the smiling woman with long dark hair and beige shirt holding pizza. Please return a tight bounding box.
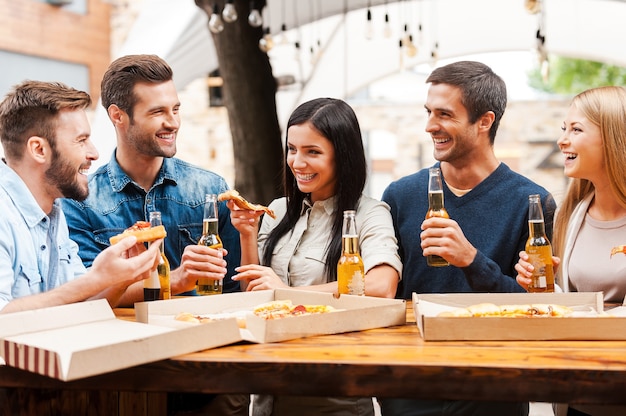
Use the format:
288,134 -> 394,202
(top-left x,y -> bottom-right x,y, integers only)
228,98 -> 402,415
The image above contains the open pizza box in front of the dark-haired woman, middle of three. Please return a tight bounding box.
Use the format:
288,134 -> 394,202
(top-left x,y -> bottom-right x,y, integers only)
135,289 -> 406,343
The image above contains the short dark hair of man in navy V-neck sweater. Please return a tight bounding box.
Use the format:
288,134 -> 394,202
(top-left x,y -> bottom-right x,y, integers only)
426,61 -> 507,144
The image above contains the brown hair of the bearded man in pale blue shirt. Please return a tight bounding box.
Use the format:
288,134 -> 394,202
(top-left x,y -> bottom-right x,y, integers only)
0,80 -> 91,160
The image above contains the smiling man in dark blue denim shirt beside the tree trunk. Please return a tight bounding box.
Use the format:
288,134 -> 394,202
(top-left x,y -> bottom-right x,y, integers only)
63,55 -> 241,302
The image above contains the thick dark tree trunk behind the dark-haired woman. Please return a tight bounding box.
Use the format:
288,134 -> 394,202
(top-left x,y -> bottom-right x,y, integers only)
195,0 -> 284,204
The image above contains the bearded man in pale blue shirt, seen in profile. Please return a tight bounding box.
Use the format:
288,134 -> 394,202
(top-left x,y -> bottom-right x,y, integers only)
0,81 -> 160,313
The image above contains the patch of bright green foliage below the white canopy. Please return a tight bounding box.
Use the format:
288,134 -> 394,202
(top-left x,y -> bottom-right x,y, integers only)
528,56 -> 626,95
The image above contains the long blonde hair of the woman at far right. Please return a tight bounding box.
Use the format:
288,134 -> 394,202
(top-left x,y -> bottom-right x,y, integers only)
553,86 -> 626,258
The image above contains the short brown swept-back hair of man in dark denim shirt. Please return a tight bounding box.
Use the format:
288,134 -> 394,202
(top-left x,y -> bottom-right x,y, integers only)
100,55 -> 173,120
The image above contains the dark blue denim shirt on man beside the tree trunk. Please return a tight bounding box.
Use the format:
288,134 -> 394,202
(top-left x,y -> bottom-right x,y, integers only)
63,152 -> 241,292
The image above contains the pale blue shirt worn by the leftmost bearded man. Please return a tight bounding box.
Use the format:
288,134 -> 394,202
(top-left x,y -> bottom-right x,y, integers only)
0,162 -> 86,310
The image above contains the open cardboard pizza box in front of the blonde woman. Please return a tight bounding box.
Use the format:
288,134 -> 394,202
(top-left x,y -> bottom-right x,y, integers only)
413,292 -> 626,341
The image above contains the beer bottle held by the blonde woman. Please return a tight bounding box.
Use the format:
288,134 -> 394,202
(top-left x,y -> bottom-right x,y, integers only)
526,195 -> 554,292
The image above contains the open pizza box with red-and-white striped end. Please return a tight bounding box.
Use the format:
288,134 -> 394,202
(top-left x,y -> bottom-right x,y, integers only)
0,299 -> 240,381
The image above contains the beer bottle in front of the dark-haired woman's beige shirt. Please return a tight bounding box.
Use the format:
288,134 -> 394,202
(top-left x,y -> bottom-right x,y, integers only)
337,210 -> 365,296
